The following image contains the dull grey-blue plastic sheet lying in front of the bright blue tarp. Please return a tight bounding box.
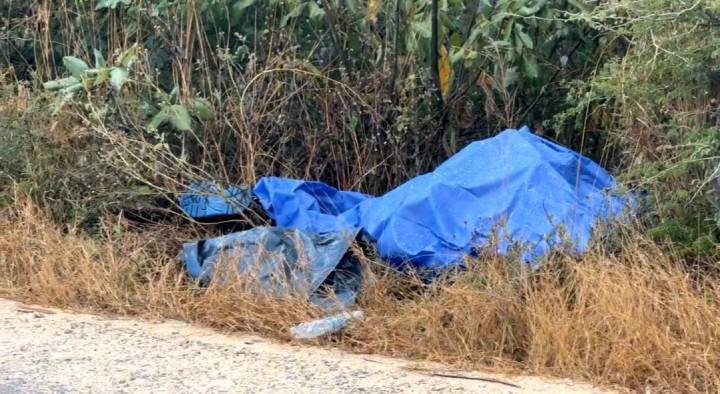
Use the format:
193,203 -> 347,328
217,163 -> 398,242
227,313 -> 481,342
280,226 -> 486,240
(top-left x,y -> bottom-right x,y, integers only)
180,227 -> 361,307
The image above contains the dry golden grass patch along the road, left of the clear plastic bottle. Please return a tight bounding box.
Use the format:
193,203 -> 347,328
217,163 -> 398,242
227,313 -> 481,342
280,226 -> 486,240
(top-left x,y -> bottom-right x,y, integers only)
0,200 -> 313,333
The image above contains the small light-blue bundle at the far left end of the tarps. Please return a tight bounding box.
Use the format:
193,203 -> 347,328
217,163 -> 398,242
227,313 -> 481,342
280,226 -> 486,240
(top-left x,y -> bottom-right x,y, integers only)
180,181 -> 252,219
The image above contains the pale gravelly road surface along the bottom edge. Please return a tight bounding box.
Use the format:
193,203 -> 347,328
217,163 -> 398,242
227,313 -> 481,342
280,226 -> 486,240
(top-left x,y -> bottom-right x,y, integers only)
0,300 -> 606,394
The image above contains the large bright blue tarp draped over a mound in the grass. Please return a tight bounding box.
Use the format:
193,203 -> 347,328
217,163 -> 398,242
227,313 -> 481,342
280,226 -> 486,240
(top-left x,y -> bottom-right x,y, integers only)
253,128 -> 627,269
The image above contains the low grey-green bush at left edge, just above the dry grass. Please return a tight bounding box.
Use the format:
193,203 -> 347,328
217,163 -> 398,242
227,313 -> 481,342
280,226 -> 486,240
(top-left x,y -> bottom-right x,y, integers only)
0,93 -> 155,228
